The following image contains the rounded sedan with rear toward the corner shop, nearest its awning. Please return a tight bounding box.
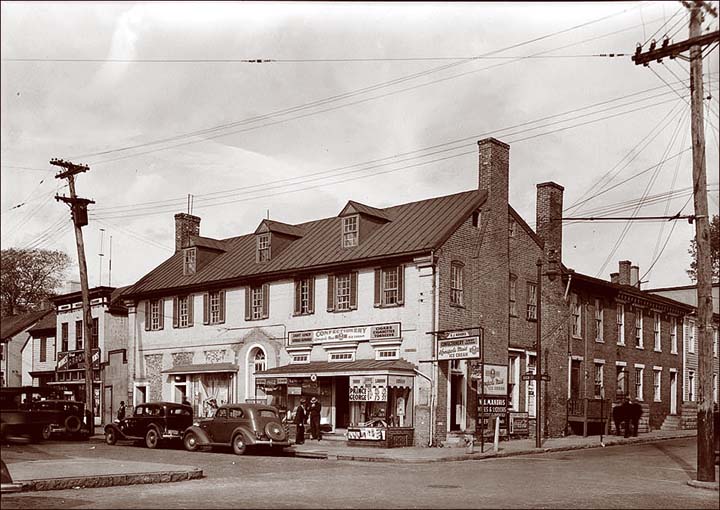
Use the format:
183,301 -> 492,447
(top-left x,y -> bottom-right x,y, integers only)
183,404 -> 290,455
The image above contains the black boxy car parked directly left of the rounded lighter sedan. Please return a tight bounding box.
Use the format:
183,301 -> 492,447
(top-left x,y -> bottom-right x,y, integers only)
105,402 -> 193,448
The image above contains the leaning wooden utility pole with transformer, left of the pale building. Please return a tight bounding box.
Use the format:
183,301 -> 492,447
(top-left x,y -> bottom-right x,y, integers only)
50,159 -> 95,434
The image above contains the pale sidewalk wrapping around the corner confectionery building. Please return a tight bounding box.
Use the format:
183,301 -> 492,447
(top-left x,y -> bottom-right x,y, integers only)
289,430 -> 697,463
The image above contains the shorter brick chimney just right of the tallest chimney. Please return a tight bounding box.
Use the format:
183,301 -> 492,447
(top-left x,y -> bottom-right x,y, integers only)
535,182 -> 565,276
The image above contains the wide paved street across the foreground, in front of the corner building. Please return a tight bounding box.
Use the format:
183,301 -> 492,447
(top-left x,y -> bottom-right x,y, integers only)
2,439 -> 717,509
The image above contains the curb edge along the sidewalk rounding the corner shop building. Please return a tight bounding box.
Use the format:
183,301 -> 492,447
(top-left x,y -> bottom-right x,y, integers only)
293,434 -> 693,464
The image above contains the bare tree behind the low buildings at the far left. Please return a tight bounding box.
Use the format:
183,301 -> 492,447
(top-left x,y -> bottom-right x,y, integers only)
0,248 -> 70,317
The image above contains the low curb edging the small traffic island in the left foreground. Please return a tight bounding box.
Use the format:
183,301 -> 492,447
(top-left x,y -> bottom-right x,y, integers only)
11,468 -> 203,492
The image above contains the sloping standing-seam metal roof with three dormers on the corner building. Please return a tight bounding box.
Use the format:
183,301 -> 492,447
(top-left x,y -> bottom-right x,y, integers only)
125,190 -> 487,298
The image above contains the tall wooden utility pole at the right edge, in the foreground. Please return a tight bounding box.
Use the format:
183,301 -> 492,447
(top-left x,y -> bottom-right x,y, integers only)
633,1 -> 720,482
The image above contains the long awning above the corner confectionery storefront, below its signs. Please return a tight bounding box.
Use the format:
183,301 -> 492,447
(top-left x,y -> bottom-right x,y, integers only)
255,359 -> 415,378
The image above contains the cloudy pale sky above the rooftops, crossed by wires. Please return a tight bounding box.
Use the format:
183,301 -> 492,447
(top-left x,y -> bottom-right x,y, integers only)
0,1 -> 720,288
